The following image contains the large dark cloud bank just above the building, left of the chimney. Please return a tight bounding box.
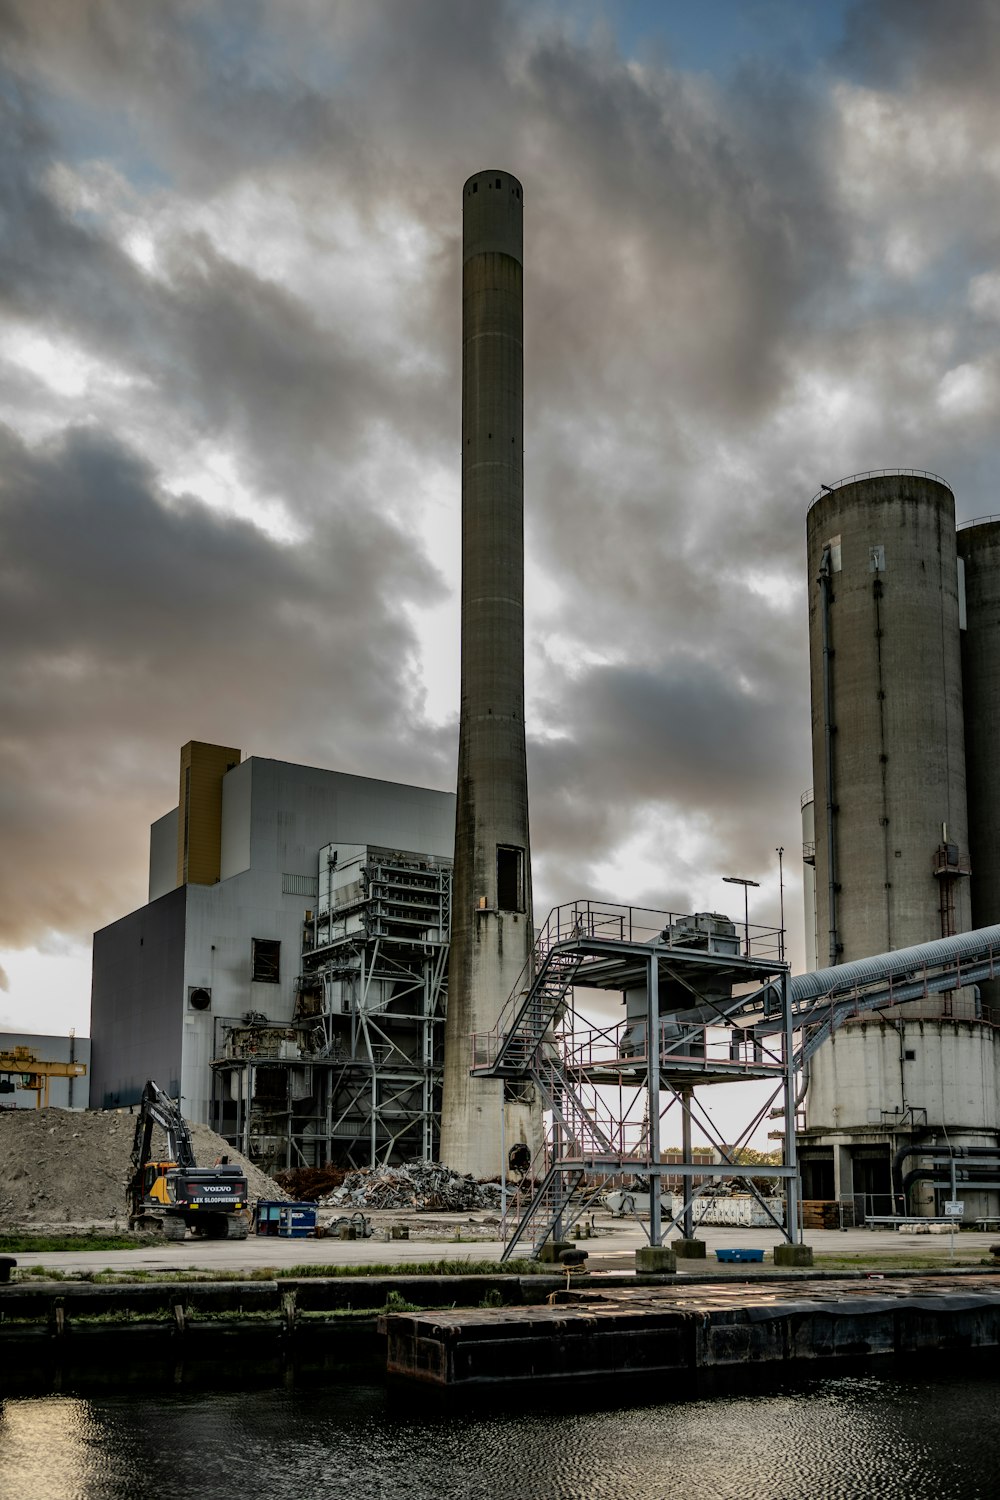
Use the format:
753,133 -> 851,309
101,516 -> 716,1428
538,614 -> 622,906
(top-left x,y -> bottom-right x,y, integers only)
0,431 -> 432,944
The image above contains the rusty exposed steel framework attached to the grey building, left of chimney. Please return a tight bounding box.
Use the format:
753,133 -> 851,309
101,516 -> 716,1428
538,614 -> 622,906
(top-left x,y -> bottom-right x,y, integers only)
213,849 -> 451,1170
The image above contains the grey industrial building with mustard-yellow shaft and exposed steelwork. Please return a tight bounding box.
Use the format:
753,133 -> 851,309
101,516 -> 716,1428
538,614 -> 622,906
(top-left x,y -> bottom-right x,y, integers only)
90,741 -> 454,1170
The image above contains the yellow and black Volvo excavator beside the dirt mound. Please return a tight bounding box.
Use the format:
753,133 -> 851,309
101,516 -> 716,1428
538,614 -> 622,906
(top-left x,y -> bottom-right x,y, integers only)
126,1079 -> 249,1239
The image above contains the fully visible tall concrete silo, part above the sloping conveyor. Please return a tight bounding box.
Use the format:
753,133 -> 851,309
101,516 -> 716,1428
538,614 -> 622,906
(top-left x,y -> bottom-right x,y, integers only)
807,471 -> 970,968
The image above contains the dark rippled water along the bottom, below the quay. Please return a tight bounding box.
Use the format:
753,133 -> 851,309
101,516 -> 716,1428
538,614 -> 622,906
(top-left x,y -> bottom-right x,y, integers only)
0,1376 -> 1000,1500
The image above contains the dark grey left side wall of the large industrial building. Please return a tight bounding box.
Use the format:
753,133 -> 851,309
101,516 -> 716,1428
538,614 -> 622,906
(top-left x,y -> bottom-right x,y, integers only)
90,885 -> 186,1109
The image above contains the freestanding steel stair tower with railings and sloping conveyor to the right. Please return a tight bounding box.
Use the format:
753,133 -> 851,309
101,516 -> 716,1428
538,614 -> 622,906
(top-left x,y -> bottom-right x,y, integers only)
471,902 -> 1000,1257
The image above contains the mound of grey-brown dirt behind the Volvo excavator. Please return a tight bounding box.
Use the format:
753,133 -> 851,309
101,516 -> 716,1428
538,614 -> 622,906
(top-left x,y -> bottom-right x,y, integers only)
0,1109 -> 288,1227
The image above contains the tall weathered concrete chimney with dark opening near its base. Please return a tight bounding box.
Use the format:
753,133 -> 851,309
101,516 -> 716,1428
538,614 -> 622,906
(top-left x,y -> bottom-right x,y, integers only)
441,171 -> 540,1178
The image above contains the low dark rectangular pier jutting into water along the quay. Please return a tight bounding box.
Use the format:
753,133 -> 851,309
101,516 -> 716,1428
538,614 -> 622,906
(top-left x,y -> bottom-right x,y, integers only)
379,1275 -> 1000,1398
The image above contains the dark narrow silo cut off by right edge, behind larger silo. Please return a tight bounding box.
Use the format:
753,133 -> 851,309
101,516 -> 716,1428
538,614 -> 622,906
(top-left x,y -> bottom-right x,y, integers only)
958,518 -> 1000,927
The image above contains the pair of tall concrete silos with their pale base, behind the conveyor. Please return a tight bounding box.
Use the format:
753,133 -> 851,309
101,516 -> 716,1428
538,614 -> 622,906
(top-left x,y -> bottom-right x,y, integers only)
799,471 -> 1000,1220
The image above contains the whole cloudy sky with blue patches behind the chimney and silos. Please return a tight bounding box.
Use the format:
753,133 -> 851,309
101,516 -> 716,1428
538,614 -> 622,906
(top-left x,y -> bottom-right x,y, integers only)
0,0 -> 1000,1032
